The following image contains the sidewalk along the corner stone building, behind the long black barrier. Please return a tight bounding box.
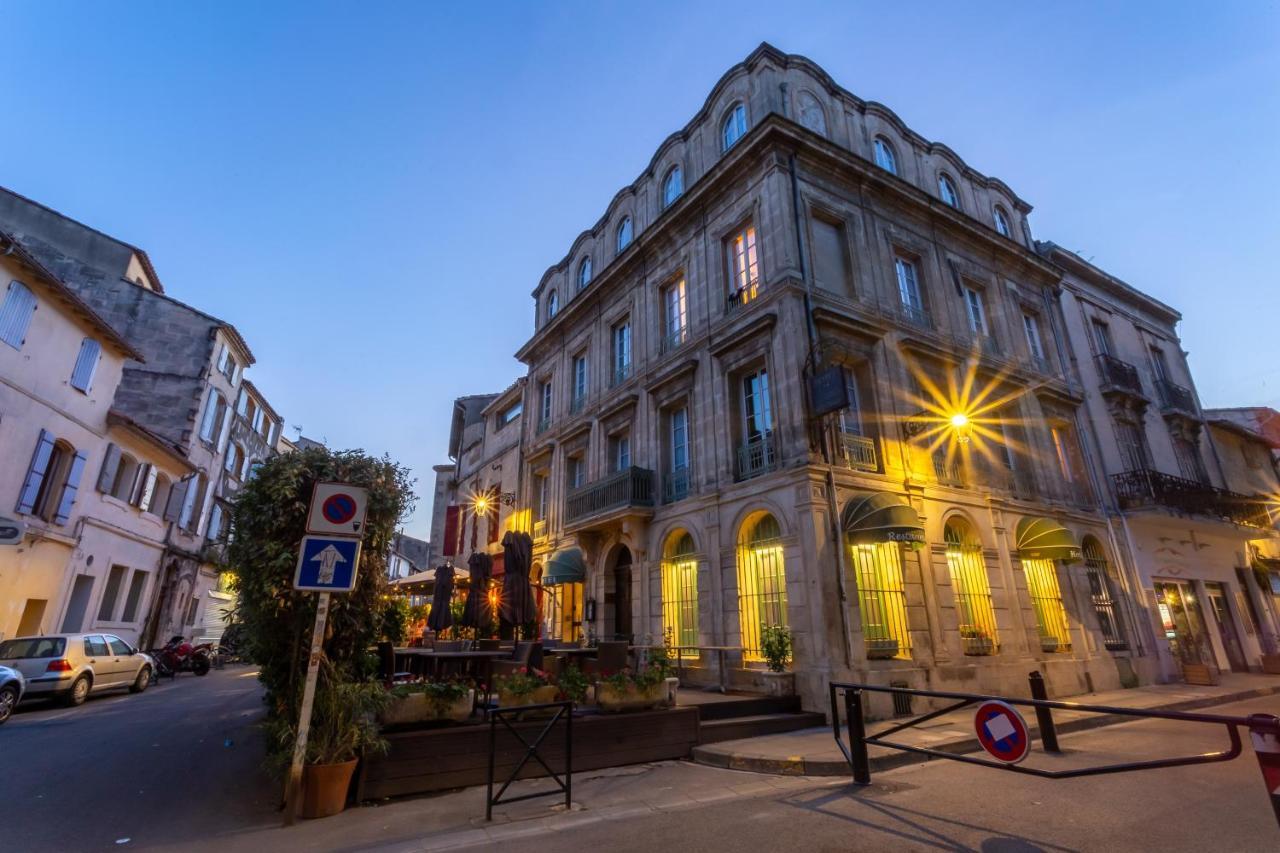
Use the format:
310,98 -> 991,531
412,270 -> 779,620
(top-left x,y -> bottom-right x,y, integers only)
694,672 -> 1280,776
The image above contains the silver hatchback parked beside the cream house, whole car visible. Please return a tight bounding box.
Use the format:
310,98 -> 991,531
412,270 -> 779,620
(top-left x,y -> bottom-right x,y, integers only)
0,634 -> 155,706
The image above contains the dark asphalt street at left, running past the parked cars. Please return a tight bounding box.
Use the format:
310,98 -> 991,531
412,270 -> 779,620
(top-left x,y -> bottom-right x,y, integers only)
0,666 -> 279,852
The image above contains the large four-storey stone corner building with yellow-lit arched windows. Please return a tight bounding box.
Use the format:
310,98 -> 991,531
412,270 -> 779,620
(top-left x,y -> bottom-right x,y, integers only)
506,45 -> 1142,707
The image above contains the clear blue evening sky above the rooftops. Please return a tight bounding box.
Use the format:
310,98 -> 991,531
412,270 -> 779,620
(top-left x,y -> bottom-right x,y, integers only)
0,1 -> 1280,537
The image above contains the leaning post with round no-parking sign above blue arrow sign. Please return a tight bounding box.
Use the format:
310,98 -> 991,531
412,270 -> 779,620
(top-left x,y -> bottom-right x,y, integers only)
284,473 -> 369,826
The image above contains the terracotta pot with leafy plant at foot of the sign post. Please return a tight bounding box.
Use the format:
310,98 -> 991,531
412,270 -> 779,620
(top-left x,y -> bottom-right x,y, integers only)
288,674 -> 390,817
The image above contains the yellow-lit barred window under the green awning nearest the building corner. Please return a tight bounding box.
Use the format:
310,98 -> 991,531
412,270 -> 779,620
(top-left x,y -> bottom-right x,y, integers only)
849,542 -> 911,660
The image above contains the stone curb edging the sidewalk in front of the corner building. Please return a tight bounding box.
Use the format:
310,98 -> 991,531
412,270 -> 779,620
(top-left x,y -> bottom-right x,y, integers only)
692,684 -> 1280,776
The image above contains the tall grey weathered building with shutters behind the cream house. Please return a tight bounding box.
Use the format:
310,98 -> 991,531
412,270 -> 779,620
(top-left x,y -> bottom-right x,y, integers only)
0,190 -> 282,646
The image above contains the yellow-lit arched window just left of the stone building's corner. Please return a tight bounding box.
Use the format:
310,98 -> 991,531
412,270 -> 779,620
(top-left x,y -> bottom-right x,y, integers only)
737,512 -> 787,661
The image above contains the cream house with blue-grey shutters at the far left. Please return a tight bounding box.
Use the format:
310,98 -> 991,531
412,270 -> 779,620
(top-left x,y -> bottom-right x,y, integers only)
0,233 -> 193,643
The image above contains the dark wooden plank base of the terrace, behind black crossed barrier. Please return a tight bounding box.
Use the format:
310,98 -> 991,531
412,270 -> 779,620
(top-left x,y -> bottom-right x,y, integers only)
356,707 -> 699,800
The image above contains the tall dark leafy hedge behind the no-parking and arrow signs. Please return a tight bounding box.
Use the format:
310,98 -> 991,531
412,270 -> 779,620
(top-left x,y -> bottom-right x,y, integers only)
225,447 -> 413,737
